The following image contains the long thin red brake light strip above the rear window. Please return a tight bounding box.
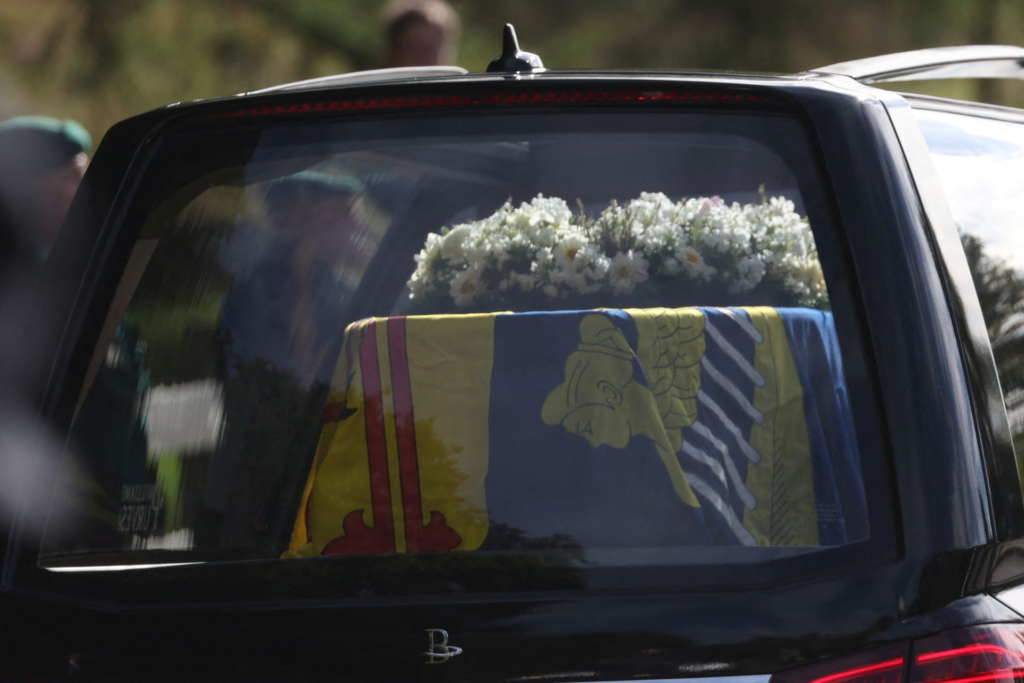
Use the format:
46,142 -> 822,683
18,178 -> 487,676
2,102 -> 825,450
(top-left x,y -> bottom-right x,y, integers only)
206,90 -> 771,119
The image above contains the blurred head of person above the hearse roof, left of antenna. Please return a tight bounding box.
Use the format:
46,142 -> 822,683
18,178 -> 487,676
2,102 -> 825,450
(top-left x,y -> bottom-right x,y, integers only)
382,0 -> 462,68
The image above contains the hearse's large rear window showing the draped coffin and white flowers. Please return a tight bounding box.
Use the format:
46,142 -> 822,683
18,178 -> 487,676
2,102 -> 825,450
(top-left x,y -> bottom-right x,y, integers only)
39,110 -> 888,591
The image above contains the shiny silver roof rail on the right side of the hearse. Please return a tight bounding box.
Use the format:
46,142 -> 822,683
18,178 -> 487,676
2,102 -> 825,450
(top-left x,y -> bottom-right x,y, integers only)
811,45 -> 1024,83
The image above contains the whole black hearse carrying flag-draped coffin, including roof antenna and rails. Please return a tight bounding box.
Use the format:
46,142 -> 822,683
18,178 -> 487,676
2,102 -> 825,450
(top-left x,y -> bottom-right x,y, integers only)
6,34 -> 1024,683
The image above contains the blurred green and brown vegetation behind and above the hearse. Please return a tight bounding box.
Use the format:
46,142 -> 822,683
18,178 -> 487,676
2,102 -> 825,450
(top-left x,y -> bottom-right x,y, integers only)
0,0 -> 1024,153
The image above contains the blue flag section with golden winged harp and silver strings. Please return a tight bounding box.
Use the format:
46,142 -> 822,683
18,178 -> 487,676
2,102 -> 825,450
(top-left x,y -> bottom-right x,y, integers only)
486,308 -> 867,548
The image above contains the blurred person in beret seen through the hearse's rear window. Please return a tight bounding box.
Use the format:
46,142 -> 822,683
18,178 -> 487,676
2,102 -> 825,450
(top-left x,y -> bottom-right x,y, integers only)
199,170 -> 376,552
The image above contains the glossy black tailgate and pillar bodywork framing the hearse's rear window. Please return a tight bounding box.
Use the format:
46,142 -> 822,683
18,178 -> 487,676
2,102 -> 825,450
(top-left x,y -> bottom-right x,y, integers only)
0,72 -> 1022,681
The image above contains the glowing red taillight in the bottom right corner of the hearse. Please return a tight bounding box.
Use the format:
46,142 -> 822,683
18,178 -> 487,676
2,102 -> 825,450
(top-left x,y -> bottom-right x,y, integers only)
772,625 -> 1024,683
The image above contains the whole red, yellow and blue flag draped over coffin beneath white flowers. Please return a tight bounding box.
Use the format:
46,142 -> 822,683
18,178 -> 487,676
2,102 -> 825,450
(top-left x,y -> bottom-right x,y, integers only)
286,308 -> 867,557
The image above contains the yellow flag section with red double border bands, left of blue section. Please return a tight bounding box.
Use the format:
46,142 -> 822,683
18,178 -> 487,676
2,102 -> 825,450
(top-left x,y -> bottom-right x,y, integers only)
285,314 -> 495,557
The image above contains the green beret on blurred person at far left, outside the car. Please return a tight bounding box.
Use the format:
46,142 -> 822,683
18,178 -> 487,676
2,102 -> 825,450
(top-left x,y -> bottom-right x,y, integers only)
0,116 -> 92,176
